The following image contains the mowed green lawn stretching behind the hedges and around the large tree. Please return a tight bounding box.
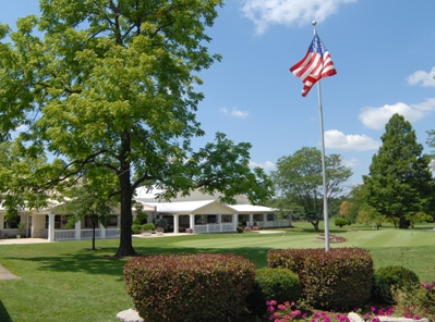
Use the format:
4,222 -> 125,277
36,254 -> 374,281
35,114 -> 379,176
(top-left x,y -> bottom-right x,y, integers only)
0,223 -> 435,322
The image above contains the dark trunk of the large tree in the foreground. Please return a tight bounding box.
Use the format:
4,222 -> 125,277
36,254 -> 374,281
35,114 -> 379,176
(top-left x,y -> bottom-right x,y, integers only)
115,132 -> 137,257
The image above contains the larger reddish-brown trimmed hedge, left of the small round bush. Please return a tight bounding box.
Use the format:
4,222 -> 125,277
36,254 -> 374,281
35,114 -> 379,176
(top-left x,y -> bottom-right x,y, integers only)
124,253 -> 255,322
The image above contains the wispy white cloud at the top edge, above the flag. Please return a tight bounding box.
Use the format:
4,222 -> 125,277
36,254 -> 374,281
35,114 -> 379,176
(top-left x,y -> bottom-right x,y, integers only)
241,0 -> 357,34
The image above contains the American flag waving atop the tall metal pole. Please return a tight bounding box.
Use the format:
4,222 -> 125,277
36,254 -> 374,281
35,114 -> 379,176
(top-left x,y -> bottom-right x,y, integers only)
290,34 -> 337,97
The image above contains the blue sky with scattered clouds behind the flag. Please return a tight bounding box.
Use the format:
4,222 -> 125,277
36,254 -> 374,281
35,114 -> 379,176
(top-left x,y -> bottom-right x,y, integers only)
0,0 -> 435,189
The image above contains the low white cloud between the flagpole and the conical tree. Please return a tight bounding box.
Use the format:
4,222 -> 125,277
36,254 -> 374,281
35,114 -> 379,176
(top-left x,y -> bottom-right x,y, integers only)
325,130 -> 380,151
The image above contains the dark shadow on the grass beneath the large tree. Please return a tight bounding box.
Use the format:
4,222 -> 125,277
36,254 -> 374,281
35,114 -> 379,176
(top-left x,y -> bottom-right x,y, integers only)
4,246 -> 270,276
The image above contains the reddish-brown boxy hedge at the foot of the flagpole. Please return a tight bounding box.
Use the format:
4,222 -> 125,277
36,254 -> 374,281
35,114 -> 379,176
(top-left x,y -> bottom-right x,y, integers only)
267,248 -> 374,311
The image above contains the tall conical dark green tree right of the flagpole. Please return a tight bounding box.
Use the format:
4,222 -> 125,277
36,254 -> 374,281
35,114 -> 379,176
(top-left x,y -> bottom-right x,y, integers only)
363,114 -> 435,228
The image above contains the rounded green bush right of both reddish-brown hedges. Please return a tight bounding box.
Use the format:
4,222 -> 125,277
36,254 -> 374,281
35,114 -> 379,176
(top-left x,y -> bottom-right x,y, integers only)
373,266 -> 420,304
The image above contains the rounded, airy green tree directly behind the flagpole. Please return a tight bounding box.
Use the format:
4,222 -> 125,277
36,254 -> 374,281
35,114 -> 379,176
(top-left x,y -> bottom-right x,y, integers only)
272,147 -> 352,231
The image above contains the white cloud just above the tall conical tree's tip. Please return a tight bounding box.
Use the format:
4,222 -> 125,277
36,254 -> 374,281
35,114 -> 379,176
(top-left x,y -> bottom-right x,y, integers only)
359,98 -> 435,130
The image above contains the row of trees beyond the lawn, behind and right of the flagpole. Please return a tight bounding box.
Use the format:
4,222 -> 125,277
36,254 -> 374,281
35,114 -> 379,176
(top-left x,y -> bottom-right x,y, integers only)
271,114 -> 435,231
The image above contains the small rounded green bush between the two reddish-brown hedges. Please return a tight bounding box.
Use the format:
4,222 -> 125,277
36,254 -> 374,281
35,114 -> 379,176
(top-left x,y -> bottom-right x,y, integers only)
248,268 -> 302,315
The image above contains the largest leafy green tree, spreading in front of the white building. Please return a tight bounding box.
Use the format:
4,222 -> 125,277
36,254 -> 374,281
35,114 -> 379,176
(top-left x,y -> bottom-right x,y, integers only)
0,0 -> 269,256
